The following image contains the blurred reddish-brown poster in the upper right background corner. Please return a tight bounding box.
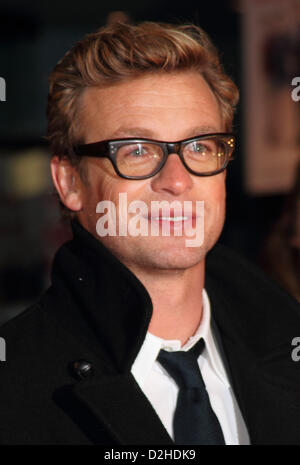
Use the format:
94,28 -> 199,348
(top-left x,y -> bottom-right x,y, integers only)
243,0 -> 300,195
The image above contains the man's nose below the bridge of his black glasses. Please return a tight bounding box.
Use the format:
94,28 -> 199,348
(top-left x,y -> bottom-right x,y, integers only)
152,153 -> 193,196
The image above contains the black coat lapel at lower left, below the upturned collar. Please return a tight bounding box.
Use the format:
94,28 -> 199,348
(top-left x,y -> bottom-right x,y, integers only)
69,374 -> 174,445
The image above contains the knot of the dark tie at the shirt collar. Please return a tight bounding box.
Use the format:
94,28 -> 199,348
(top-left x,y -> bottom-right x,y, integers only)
157,338 -> 205,389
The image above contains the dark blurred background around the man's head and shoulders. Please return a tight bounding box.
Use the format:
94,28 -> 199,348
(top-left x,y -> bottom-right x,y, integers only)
0,0 -> 300,324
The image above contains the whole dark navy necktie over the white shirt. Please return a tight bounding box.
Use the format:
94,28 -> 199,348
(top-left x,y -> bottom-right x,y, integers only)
157,338 -> 225,445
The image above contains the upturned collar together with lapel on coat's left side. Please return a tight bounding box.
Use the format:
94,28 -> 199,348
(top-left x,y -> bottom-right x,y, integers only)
48,222 -> 174,445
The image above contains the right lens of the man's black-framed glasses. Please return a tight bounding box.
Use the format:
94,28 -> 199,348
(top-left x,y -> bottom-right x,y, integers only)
183,137 -> 234,173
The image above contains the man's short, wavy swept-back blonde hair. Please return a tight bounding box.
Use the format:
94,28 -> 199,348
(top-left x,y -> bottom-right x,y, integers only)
47,22 -> 239,163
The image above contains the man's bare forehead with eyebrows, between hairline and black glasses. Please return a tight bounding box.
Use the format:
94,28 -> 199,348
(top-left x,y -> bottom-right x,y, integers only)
79,72 -> 223,142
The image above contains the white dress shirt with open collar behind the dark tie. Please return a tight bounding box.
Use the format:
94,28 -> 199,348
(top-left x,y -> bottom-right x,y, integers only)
131,289 -> 249,445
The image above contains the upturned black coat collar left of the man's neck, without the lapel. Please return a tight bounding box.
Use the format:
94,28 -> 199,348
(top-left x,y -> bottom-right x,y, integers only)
52,221 -> 152,372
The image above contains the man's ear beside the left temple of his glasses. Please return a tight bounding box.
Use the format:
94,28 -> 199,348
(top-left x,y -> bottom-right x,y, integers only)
50,155 -> 82,212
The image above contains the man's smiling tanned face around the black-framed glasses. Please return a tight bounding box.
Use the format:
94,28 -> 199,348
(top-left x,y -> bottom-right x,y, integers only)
74,72 -> 225,270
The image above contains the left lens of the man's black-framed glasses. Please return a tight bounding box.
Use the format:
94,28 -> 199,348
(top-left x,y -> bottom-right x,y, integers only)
116,142 -> 164,176
